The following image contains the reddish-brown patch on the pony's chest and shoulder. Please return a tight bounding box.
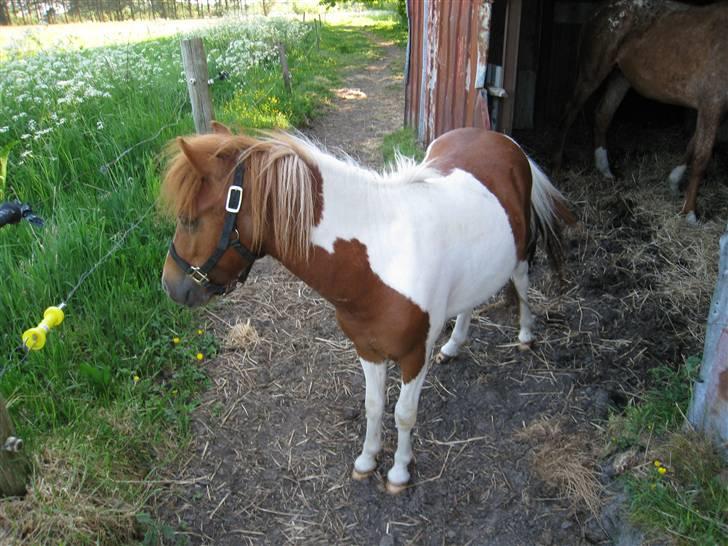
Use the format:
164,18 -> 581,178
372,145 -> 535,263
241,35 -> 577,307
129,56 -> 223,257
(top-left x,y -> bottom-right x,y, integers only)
270,239 -> 430,383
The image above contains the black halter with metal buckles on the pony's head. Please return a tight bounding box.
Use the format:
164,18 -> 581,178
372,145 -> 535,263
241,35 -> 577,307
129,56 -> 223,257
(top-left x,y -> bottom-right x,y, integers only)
169,163 -> 261,294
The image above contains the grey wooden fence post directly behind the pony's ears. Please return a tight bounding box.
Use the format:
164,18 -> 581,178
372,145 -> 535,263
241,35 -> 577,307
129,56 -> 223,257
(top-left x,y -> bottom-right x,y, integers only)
181,38 -> 215,134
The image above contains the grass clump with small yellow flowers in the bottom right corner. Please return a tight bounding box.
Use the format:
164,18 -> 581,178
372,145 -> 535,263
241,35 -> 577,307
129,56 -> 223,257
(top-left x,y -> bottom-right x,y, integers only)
609,357 -> 728,546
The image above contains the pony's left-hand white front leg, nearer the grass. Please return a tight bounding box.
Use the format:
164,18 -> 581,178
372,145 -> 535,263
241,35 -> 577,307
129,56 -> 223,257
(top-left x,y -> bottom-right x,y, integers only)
351,358 -> 387,480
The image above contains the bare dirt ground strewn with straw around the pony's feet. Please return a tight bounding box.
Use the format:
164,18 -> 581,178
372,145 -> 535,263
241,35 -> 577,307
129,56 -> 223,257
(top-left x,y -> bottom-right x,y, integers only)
151,35 -> 728,546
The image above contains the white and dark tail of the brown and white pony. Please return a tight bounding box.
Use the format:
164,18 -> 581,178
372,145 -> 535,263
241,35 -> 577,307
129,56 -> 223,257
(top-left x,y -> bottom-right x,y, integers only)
528,158 -> 576,277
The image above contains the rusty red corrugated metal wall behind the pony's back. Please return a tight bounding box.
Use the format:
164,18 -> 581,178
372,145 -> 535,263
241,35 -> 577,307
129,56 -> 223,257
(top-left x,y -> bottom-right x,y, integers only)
405,0 -> 493,145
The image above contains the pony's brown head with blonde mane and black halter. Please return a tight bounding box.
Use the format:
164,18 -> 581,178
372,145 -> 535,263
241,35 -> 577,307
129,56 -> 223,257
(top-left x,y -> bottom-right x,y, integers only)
161,122 -> 317,306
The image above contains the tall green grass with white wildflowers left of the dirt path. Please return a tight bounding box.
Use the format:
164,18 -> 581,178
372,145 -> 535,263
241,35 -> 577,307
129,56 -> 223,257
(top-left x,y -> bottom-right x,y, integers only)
0,10 -> 400,544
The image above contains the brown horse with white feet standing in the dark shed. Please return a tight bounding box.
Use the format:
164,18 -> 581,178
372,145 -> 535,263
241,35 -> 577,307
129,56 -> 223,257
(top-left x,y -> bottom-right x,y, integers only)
553,0 -> 728,223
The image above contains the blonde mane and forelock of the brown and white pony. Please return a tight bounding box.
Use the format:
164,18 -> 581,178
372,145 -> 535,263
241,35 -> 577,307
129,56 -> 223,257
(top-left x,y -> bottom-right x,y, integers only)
161,132 -> 320,261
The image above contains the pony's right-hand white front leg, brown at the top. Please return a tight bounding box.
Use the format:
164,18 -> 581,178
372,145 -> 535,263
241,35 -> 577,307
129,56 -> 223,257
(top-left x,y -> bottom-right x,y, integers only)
387,344 -> 432,495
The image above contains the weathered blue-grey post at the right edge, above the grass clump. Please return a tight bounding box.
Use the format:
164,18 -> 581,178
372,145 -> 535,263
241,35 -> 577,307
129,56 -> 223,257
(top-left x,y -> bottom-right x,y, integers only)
688,227 -> 728,455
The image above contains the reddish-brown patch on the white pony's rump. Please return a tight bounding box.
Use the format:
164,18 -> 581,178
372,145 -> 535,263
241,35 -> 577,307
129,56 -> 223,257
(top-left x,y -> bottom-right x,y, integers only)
426,128 -> 531,260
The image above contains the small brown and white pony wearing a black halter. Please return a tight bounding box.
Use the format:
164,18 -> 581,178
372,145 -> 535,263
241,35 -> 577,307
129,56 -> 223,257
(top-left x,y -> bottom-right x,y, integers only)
162,124 -> 573,492
